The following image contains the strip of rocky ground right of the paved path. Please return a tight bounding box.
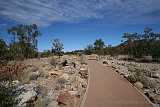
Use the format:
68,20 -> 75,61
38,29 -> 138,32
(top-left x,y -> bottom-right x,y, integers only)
100,57 -> 160,105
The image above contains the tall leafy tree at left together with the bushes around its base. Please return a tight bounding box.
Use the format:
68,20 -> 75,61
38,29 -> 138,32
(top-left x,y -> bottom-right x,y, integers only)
8,24 -> 41,59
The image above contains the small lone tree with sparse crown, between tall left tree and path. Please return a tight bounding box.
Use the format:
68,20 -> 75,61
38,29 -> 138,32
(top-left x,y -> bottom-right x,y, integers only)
52,39 -> 64,57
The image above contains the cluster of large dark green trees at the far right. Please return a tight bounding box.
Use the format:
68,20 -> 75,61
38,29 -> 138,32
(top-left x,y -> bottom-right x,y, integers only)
118,28 -> 160,59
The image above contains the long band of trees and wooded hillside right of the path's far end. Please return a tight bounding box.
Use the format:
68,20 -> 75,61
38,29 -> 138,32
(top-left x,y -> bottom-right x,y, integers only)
84,28 -> 160,61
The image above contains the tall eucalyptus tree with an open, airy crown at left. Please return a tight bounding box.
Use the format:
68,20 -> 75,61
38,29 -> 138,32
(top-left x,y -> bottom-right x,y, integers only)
8,24 -> 42,59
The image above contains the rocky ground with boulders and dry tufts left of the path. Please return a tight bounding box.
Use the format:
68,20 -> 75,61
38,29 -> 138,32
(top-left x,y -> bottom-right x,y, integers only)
1,56 -> 88,107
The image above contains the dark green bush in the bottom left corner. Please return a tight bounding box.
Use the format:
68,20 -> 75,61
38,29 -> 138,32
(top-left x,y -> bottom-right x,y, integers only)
0,86 -> 14,107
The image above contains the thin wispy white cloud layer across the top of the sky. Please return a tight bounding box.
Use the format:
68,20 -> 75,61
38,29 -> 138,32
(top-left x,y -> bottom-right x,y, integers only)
0,0 -> 160,27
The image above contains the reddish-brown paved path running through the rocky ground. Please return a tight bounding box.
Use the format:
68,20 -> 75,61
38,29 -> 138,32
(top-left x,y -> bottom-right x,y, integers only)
84,60 -> 152,107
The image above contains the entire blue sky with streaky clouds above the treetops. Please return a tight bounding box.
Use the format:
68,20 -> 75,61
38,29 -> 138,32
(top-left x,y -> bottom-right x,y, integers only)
0,0 -> 160,51
